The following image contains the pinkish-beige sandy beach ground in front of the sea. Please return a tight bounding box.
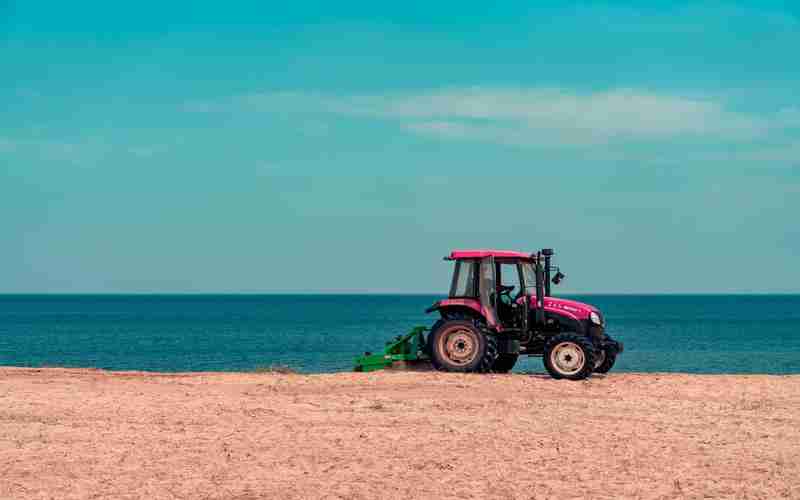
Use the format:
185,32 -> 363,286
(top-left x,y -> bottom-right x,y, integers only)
0,368 -> 800,499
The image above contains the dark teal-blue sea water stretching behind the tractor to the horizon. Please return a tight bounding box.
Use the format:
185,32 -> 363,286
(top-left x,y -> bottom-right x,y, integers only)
0,295 -> 800,374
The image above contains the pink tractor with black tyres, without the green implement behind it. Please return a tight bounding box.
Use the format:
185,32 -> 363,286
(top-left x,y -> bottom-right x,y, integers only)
422,249 -> 623,380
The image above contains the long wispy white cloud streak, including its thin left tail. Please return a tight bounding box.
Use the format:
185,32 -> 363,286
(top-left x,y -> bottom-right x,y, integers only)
185,87 -> 788,146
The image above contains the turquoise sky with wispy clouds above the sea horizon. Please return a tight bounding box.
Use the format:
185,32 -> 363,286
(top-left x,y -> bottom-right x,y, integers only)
0,0 -> 800,293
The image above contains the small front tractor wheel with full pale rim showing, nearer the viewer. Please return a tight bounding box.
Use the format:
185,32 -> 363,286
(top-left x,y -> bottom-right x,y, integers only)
544,333 -> 595,380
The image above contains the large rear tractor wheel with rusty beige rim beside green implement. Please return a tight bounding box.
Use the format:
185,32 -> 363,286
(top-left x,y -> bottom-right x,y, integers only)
429,320 -> 497,373
